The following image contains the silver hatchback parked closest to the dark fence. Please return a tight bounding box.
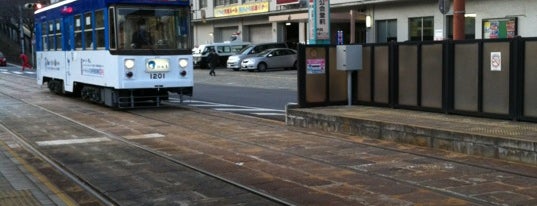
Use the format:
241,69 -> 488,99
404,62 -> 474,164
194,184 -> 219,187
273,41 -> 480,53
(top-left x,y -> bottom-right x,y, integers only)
241,48 -> 297,72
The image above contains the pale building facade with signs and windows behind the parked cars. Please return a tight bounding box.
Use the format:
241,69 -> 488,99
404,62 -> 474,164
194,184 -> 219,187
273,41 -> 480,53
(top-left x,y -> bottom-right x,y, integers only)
192,0 -> 537,45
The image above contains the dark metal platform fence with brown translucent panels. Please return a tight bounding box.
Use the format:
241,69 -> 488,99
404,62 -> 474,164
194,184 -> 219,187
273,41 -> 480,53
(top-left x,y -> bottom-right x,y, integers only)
298,38 -> 537,122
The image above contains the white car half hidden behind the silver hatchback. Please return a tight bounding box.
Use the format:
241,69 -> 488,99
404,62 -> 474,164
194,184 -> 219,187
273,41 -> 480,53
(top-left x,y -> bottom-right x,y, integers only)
226,42 -> 288,71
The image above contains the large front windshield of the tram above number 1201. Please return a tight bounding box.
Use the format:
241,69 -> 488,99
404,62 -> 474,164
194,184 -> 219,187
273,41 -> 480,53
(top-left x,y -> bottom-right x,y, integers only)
116,7 -> 190,50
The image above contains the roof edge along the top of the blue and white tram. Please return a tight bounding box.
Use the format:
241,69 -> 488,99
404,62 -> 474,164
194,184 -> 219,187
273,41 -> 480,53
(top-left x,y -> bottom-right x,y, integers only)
34,0 -> 190,15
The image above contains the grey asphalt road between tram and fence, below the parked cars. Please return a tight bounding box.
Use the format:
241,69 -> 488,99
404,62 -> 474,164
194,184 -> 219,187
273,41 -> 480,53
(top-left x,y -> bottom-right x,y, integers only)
193,69 -> 298,110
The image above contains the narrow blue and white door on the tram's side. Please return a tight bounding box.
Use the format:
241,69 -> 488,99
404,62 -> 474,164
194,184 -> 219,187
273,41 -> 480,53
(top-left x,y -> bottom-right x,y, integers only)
62,17 -> 75,90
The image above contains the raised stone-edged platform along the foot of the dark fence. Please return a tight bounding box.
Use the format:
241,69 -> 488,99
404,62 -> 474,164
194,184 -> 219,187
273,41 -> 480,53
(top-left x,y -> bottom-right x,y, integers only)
286,105 -> 537,164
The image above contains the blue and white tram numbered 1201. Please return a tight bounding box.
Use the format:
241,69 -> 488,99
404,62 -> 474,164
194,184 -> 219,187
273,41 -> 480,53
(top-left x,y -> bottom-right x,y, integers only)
35,0 -> 194,108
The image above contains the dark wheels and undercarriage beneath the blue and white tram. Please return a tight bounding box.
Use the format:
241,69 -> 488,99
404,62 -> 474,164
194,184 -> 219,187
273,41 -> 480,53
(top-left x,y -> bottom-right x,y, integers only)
46,79 -> 193,108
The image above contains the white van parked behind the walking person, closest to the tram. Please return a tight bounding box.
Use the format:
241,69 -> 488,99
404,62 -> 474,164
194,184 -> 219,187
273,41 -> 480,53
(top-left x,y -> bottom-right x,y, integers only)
192,42 -> 250,68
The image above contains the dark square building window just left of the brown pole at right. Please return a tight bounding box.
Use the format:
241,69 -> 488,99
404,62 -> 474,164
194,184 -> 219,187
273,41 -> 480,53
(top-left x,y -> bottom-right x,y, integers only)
408,16 -> 434,41
